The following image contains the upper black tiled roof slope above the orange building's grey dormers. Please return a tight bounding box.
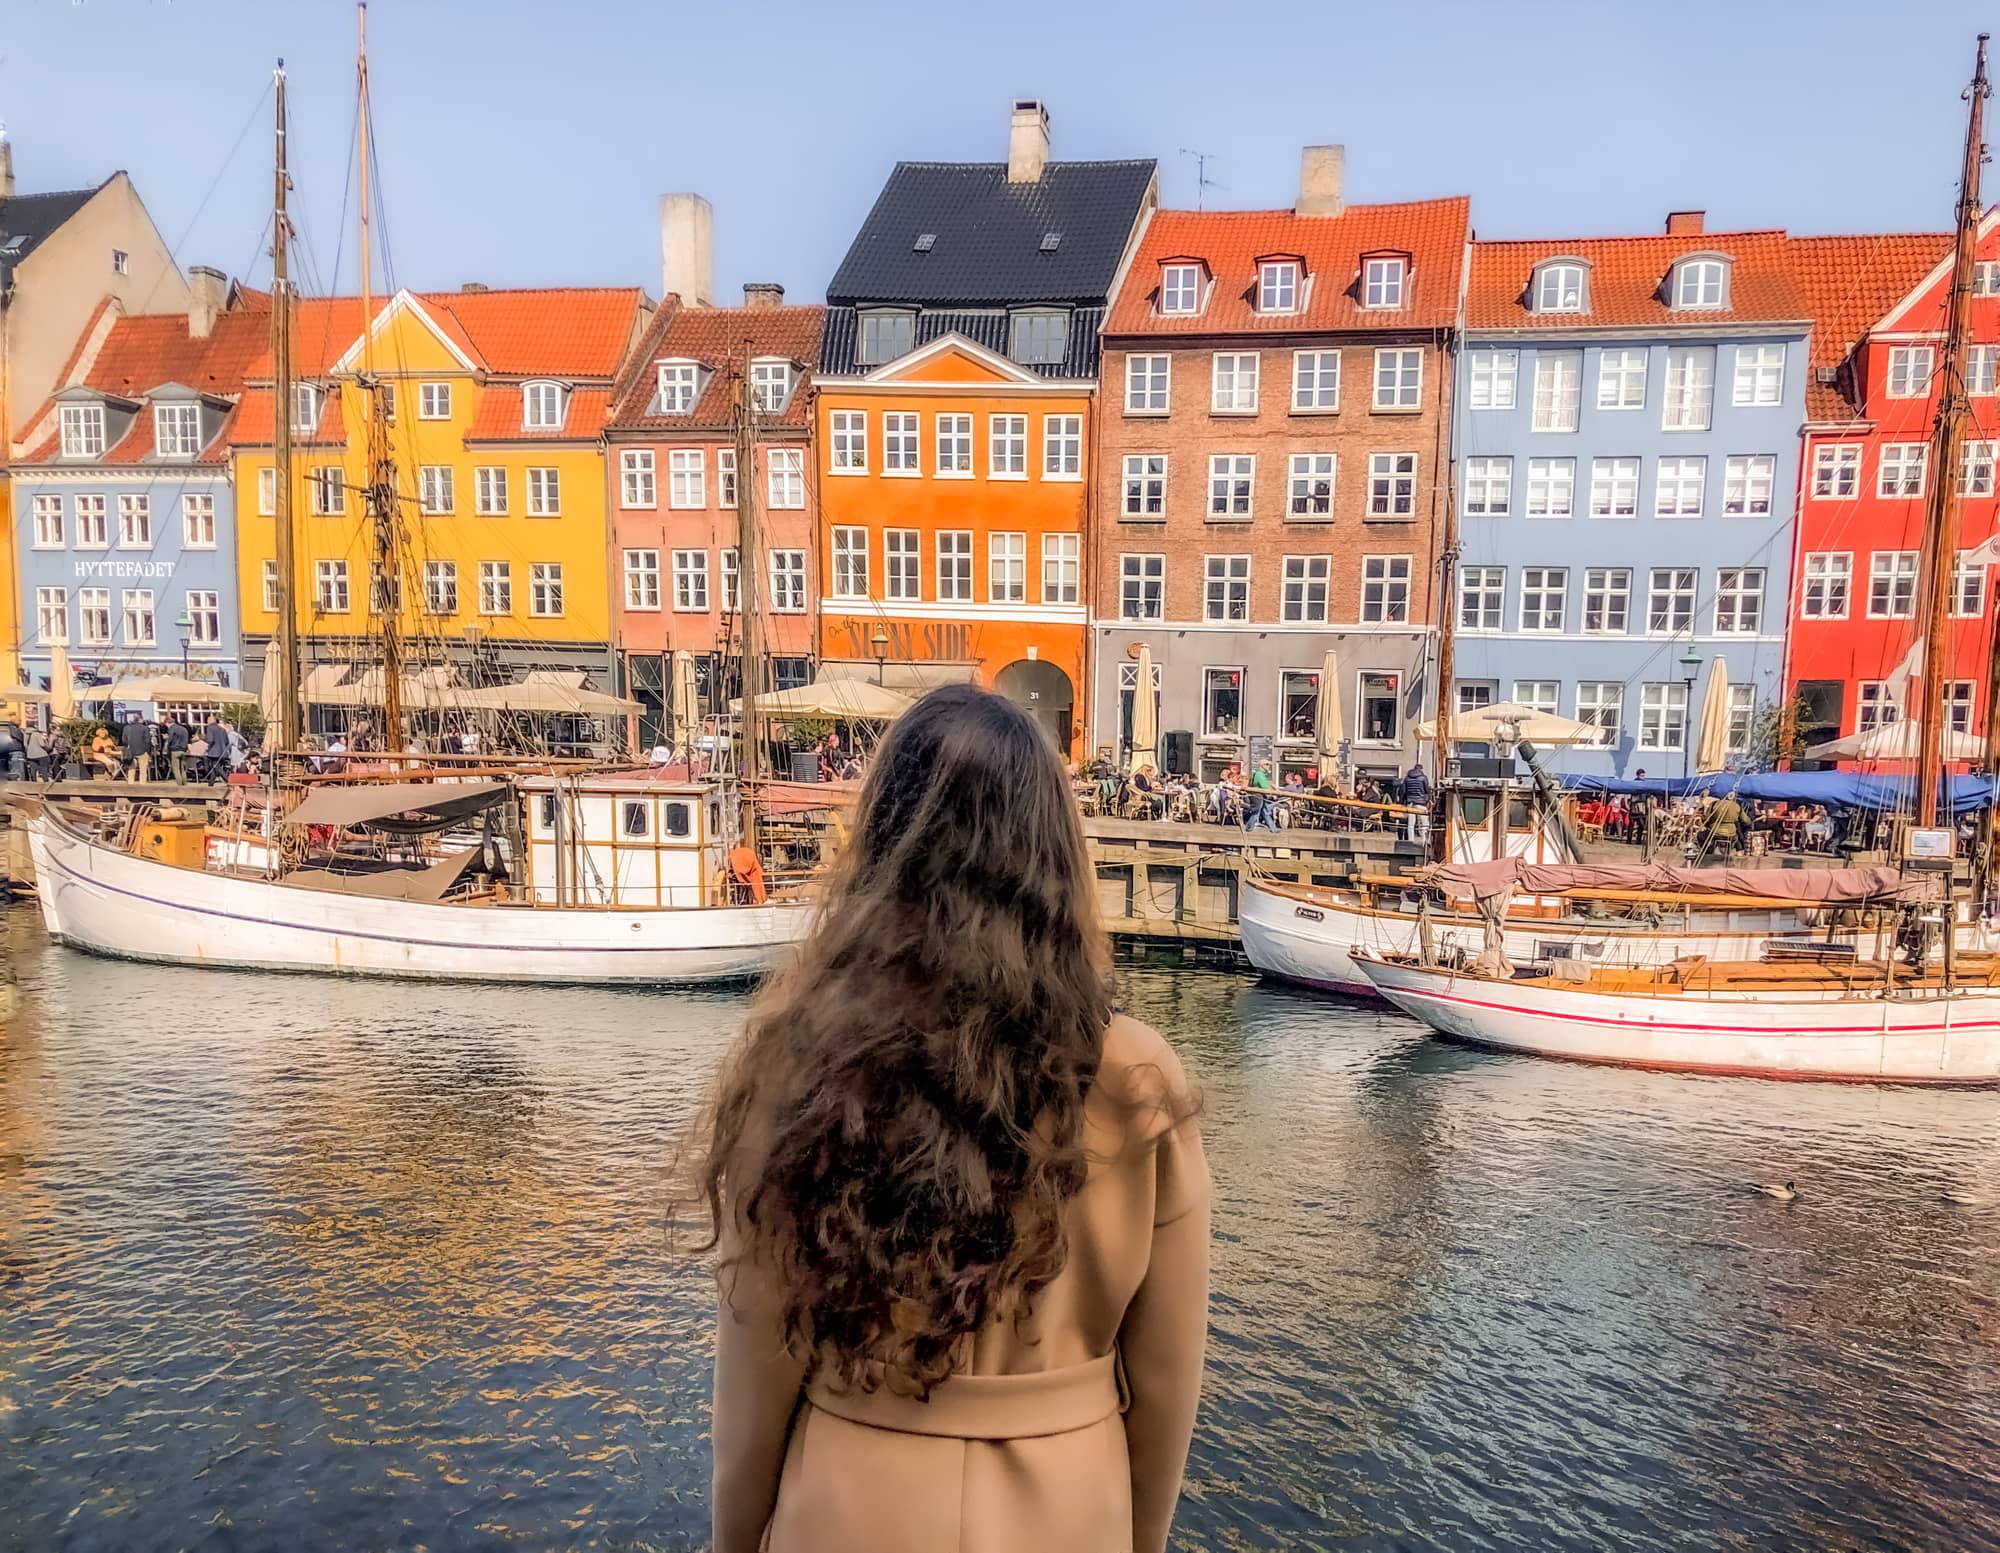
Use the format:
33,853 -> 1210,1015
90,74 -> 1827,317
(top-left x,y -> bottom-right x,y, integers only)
826,160 -> 1154,306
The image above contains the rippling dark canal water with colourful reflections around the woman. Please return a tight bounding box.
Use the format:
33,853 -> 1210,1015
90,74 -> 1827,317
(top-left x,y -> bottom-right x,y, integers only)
0,909 -> 2000,1553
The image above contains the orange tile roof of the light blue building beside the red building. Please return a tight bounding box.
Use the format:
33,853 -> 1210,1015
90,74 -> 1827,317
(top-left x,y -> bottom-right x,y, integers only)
1466,232 -> 1808,328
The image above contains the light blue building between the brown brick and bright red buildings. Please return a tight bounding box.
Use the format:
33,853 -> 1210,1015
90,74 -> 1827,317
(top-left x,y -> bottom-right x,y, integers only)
1452,224 -> 1810,777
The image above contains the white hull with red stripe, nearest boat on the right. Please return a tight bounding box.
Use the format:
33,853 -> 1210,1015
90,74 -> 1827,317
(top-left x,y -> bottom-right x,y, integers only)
1356,951 -> 2000,1085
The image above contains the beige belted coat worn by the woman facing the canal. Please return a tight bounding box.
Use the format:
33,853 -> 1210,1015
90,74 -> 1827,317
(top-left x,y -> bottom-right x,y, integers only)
710,1017 -> 1208,1553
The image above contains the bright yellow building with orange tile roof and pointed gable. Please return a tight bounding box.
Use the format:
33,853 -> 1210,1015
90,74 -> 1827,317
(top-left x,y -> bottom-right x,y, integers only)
230,288 -> 650,704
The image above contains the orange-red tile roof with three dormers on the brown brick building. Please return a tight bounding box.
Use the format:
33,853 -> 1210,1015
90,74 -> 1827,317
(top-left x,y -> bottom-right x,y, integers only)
1104,196 -> 1470,336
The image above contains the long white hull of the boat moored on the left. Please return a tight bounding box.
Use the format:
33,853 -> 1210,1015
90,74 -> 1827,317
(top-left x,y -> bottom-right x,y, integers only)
26,813 -> 810,985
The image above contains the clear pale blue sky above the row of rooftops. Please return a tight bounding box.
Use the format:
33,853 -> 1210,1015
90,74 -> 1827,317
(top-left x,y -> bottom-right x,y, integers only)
0,0 -> 2000,300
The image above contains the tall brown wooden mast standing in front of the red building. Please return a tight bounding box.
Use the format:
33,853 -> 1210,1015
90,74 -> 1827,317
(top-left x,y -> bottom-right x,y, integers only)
1916,32 -> 1992,825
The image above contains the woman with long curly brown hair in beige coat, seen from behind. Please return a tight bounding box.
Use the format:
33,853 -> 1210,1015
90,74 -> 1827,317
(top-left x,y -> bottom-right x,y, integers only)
700,686 -> 1208,1553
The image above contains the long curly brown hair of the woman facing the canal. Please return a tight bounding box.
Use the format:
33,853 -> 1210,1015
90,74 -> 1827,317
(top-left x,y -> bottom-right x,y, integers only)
698,684 -> 1112,1395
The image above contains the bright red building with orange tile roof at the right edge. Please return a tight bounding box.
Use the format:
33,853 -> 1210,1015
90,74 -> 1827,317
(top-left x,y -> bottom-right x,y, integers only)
1786,229 -> 2000,744
